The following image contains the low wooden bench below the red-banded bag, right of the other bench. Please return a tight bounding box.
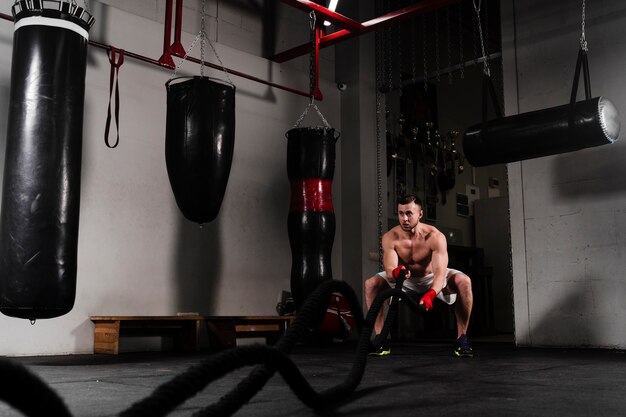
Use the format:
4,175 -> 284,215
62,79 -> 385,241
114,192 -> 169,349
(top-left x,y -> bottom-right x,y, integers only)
204,316 -> 293,348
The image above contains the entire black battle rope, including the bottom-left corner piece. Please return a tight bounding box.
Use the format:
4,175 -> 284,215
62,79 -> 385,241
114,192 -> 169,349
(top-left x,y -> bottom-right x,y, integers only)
0,271 -> 419,417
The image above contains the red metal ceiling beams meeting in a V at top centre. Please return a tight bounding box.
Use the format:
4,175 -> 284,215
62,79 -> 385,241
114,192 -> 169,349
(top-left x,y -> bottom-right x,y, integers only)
270,0 -> 460,62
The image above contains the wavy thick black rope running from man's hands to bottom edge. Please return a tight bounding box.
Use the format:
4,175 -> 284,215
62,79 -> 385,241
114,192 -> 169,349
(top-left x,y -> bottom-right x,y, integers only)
120,274 -> 418,417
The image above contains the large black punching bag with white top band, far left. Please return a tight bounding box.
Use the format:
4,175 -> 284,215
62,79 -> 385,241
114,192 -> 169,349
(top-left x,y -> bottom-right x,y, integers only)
0,1 -> 93,319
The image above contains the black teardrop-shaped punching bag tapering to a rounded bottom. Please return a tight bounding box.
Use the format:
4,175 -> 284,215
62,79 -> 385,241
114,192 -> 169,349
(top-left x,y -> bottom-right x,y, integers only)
165,77 -> 235,224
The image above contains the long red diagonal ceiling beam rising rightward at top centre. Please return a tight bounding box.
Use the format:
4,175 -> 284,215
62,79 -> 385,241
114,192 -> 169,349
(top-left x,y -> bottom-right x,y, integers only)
270,0 -> 460,62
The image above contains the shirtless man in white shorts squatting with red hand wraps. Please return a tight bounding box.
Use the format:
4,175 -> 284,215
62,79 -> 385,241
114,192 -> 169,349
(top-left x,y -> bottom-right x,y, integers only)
365,195 -> 473,356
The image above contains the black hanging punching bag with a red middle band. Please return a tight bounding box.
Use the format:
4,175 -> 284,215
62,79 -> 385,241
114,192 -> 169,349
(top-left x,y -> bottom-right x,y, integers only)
287,127 -> 338,309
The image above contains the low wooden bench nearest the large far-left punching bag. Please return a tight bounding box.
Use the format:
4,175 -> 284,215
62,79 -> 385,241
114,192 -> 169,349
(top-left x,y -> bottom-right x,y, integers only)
90,315 -> 202,355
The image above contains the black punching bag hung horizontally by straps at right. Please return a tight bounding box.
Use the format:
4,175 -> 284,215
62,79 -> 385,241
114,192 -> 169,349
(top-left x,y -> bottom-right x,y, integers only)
463,97 -> 620,167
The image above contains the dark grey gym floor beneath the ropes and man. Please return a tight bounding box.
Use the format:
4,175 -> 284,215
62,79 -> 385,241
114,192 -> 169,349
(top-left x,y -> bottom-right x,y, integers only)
0,343 -> 626,417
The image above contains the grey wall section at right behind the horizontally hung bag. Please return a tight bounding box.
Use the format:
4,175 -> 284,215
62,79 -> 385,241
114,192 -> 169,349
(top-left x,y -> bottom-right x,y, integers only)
502,0 -> 626,348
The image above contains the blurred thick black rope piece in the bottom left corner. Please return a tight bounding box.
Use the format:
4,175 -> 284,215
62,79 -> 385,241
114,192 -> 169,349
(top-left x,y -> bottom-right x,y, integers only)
0,358 -> 72,417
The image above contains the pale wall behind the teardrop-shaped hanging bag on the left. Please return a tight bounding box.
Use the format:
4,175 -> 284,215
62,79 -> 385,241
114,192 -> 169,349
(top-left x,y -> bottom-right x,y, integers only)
0,0 -> 342,355
